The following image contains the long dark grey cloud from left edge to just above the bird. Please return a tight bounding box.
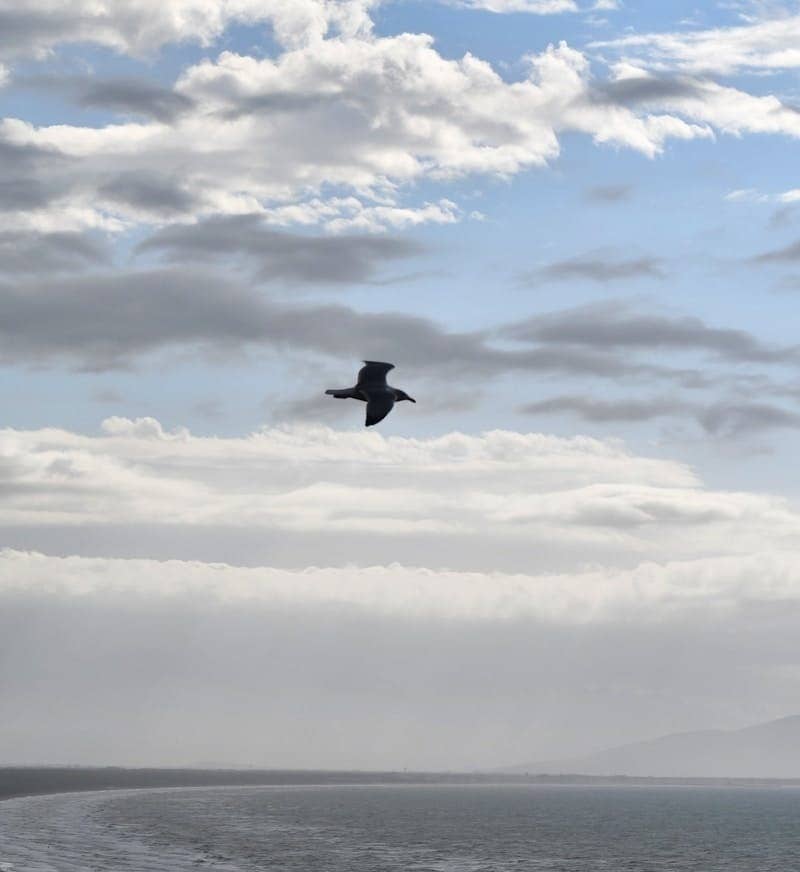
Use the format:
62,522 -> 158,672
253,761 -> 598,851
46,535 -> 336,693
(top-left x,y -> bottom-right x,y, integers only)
0,269 -> 412,369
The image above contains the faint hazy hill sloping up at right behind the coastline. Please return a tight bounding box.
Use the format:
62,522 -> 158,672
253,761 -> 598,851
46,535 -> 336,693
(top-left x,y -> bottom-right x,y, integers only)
505,715 -> 800,778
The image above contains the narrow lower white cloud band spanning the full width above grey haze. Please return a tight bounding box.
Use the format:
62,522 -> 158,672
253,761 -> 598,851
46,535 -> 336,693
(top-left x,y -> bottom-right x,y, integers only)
0,549 -> 800,626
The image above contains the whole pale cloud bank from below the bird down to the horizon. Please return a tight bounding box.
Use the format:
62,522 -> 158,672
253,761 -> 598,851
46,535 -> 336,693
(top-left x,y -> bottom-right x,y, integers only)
0,417 -> 800,768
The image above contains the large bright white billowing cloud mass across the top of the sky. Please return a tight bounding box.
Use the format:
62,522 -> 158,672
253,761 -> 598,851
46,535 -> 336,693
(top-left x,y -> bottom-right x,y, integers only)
0,0 -> 800,238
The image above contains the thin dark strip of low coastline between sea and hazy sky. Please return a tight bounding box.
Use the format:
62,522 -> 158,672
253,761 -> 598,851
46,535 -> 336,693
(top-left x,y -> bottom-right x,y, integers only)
0,766 -> 800,801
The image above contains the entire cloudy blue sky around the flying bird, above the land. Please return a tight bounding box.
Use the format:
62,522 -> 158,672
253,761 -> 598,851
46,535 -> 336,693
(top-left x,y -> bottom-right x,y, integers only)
0,0 -> 800,769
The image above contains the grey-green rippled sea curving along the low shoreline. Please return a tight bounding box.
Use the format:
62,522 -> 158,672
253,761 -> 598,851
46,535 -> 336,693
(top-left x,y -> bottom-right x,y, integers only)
0,785 -> 800,872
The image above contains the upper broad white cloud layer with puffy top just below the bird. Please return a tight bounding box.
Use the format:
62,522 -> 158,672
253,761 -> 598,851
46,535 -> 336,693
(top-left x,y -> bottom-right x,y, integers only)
0,418 -> 800,569
